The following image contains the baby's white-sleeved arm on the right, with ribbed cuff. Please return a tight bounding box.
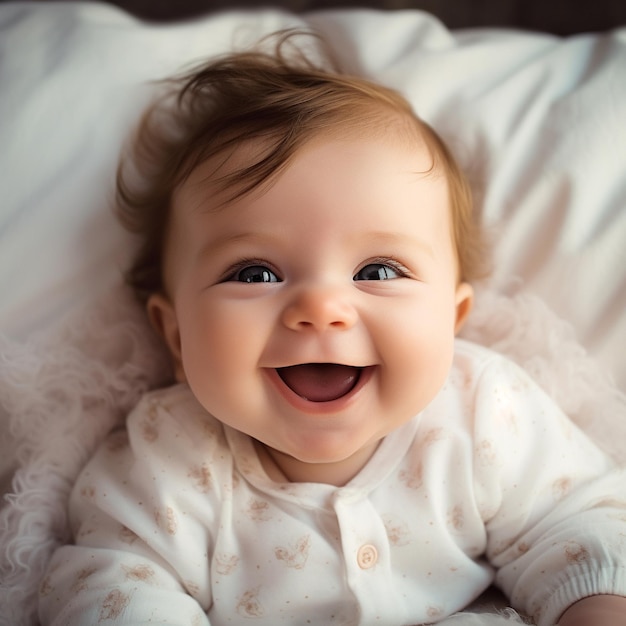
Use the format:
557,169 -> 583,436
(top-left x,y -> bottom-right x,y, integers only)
476,354 -> 626,626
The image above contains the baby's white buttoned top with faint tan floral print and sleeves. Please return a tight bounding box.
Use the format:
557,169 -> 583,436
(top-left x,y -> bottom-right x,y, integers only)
40,340 -> 626,626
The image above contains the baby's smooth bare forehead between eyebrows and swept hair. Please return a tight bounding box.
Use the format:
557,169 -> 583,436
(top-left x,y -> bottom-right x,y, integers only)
172,130 -> 450,245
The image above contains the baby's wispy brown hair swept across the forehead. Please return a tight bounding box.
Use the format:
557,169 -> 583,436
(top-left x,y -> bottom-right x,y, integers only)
117,32 -> 485,301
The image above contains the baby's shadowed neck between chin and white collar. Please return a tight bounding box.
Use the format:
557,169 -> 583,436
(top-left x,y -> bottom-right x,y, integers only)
256,441 -> 378,487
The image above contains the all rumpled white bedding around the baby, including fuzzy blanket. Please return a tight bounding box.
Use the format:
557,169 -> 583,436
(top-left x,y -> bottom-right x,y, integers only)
0,2 -> 626,625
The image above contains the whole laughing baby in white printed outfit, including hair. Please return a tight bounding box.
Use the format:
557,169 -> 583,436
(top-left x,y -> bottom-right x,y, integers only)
40,35 -> 626,626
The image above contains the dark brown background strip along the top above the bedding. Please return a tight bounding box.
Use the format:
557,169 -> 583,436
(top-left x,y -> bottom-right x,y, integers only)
8,0 -> 626,35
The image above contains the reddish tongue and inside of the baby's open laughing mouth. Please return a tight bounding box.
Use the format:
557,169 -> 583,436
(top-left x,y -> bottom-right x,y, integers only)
277,363 -> 359,402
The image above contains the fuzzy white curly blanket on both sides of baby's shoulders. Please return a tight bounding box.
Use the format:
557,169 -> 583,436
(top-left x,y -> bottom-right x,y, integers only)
0,288 -> 626,626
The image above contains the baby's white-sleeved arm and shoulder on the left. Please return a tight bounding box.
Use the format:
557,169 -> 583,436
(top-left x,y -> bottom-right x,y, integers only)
39,392 -> 218,626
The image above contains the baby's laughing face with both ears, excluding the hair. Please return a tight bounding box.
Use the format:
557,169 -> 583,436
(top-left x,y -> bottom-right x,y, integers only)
149,133 -> 471,480
